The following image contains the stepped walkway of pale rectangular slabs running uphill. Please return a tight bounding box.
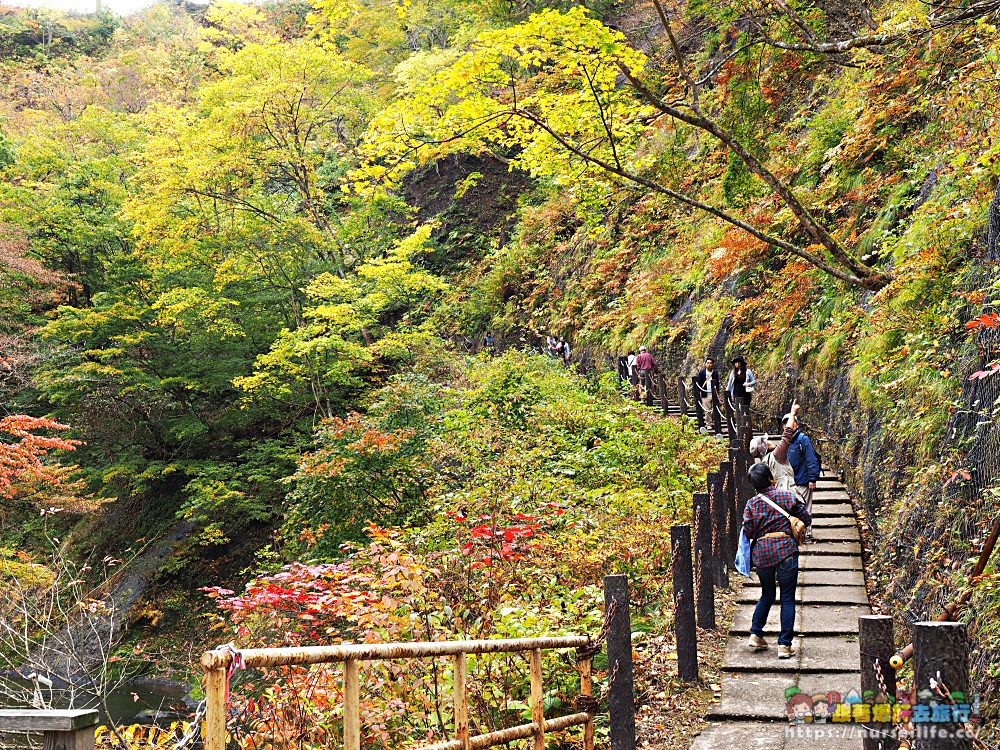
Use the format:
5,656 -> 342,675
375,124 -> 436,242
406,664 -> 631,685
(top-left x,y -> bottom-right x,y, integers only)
691,472 -> 871,750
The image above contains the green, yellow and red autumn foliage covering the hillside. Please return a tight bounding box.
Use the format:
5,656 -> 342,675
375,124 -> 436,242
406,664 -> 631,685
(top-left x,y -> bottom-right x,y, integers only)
0,0 -> 1000,746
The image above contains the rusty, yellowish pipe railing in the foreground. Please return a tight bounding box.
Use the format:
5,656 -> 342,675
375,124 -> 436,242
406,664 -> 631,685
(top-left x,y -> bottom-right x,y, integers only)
201,636 -> 594,750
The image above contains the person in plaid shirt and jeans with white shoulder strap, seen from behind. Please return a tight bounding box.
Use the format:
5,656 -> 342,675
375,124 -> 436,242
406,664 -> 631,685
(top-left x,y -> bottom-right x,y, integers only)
743,464 -> 812,659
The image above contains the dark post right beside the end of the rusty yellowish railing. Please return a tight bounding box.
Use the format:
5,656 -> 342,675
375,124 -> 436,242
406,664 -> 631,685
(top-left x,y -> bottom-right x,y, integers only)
604,576 -> 636,750
